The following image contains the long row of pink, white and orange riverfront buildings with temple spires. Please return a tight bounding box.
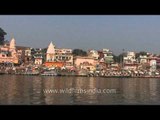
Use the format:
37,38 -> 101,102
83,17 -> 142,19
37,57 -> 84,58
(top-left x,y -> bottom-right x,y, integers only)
0,38 -> 160,77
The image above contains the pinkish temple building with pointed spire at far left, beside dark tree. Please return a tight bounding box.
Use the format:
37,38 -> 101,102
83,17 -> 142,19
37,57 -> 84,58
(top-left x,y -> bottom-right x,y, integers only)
0,38 -> 18,64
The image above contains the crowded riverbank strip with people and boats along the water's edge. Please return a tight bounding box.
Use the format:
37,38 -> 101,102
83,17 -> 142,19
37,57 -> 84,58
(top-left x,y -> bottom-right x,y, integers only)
0,66 -> 160,78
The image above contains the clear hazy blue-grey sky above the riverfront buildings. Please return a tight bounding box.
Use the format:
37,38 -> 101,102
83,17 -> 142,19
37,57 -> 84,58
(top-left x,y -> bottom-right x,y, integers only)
0,15 -> 160,54
